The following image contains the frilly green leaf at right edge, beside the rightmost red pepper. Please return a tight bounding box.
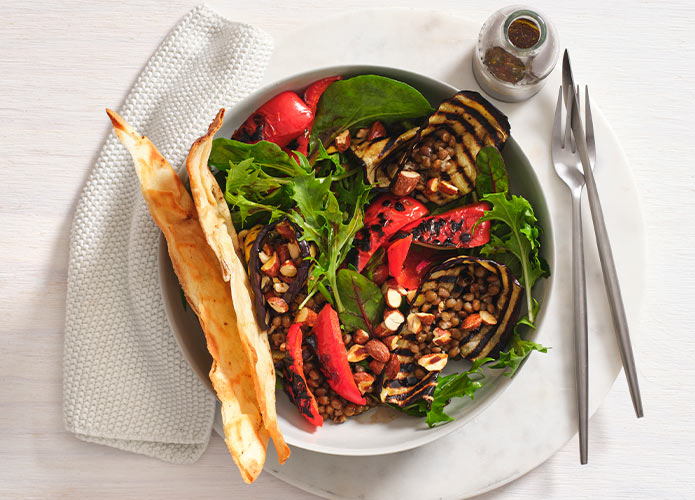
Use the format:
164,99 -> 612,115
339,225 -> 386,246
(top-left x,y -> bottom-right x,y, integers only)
477,189 -> 549,323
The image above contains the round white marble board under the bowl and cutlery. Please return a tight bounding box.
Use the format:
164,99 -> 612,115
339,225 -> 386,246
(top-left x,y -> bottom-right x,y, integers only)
251,8 -> 645,500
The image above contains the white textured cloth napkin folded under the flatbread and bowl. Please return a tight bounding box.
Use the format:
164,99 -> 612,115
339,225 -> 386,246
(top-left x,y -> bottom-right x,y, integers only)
63,6 -> 272,463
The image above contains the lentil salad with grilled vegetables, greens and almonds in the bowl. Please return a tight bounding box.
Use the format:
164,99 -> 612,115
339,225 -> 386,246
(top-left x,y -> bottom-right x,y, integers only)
208,75 -> 548,426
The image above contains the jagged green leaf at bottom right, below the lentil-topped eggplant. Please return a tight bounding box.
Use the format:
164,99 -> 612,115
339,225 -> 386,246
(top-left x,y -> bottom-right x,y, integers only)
404,358 -> 492,427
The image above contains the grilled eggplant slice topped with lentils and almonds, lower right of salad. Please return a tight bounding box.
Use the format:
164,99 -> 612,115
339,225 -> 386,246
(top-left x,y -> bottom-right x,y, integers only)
380,257 -> 523,407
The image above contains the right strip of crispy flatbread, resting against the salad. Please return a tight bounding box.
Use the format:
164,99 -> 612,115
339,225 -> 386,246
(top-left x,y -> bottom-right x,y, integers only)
186,109 -> 290,463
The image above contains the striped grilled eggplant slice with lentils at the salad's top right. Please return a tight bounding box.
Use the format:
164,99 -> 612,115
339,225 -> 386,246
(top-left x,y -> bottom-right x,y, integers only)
353,91 -> 510,205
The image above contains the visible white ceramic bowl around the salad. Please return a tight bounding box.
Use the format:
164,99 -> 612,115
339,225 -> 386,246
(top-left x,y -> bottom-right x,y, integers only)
159,66 -> 553,455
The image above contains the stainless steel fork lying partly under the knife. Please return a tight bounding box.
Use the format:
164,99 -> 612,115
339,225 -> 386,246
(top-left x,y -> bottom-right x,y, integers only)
552,87 -> 595,464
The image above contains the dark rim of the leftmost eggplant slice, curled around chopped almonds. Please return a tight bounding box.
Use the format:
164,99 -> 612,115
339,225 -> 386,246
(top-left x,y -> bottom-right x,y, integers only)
249,219 -> 311,330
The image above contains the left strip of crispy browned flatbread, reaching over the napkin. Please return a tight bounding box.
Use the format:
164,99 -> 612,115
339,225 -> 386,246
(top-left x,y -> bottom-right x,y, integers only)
106,109 -> 269,483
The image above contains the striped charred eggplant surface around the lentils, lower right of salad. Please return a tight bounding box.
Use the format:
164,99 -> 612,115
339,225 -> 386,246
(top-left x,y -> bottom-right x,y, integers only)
379,256 -> 523,407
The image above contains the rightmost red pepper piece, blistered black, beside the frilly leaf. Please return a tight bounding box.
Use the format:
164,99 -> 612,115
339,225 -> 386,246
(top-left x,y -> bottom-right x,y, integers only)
401,201 -> 491,248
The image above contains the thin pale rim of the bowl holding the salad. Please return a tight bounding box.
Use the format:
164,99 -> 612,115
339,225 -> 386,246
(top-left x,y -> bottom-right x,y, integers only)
158,64 -> 555,456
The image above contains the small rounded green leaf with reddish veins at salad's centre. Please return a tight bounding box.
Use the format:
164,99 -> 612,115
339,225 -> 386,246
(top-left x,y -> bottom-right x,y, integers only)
337,269 -> 384,331
